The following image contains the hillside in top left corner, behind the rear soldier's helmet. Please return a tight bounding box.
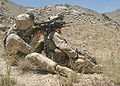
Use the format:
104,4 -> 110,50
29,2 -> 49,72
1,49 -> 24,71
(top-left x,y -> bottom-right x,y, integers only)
0,0 -> 28,24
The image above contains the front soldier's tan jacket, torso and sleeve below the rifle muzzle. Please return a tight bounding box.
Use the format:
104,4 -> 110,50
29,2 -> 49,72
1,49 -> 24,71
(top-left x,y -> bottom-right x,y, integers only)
46,31 -> 77,64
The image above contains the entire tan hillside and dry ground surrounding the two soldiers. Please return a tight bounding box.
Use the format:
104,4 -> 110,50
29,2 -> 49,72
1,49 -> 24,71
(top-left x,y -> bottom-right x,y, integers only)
0,0 -> 120,86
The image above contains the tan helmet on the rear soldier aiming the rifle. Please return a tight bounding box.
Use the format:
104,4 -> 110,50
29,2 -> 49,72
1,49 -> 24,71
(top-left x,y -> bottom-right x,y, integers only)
15,13 -> 34,30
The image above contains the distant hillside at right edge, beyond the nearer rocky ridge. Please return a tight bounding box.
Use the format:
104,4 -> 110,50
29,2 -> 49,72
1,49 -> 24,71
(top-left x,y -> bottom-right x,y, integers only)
105,9 -> 120,24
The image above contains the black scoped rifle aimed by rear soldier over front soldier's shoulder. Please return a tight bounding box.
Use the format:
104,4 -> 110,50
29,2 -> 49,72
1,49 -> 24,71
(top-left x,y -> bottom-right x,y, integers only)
27,15 -> 67,35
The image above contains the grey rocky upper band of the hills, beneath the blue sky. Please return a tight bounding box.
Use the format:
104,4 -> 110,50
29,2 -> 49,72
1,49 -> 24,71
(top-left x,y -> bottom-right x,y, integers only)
0,0 -> 119,28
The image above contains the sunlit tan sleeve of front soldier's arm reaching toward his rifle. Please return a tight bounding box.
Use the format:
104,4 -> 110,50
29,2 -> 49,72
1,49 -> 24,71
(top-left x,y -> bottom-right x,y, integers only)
53,32 -> 78,58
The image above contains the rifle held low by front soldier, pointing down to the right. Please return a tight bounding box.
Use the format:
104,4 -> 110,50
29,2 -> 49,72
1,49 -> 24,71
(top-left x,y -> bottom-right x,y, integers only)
76,49 -> 97,65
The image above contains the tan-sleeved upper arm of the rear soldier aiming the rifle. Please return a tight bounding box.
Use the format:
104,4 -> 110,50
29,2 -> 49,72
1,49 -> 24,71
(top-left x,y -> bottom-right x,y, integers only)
5,34 -> 32,54
